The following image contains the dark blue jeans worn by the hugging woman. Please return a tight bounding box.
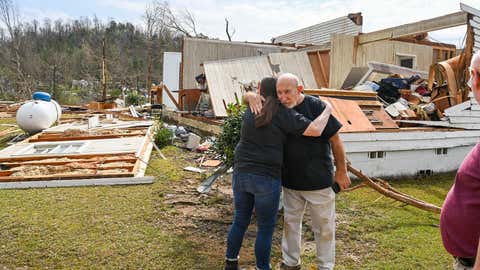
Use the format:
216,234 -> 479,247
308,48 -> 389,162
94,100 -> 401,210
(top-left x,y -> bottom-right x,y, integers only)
226,172 -> 282,270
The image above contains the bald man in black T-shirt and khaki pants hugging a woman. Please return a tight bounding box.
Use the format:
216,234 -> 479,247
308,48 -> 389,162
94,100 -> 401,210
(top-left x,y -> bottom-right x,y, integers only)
246,73 -> 350,270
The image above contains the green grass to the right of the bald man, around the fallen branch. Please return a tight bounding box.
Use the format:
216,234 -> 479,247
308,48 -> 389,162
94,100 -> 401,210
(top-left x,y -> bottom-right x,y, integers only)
318,174 -> 455,269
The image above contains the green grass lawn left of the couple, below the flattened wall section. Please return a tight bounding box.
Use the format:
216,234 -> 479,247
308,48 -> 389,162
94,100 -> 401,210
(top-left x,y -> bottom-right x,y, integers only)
0,149 -> 218,269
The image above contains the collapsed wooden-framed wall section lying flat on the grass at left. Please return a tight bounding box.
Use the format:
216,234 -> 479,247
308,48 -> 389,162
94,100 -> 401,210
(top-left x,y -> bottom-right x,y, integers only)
0,117 -> 153,188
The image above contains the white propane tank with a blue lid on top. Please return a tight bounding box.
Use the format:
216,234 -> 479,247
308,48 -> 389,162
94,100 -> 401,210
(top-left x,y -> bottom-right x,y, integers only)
17,92 -> 62,134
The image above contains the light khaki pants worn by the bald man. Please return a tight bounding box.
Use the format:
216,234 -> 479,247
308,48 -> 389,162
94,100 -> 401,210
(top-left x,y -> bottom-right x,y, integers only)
282,187 -> 335,269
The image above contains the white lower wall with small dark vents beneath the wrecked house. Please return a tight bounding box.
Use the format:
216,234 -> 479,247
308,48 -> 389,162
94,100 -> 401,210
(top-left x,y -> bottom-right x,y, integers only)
340,130 -> 480,177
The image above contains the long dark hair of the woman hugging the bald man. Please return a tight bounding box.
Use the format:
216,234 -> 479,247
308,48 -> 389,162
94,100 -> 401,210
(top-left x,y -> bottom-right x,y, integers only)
255,77 -> 280,128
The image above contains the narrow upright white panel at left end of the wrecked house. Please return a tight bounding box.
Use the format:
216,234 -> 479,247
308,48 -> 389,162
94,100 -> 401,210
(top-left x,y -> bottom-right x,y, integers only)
163,52 -> 182,108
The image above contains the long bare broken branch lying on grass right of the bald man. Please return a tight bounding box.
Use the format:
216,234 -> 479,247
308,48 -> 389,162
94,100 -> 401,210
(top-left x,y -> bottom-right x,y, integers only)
347,163 -> 442,213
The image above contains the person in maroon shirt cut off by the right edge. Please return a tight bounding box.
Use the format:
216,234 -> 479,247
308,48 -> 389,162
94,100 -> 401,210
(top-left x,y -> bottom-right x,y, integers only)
440,52 -> 480,270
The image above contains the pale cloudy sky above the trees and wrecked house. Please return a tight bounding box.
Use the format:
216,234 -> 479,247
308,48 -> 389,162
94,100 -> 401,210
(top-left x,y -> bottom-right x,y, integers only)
13,0 -> 480,46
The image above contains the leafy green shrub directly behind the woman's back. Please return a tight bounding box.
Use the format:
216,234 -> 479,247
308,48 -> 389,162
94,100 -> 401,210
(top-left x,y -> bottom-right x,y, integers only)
214,104 -> 246,166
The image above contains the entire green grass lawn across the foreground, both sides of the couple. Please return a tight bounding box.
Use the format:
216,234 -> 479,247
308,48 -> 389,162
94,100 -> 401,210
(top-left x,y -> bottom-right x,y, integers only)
0,146 -> 454,269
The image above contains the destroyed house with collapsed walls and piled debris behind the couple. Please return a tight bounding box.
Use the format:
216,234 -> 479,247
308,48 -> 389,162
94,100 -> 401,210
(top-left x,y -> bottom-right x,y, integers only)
152,4 -> 480,179
